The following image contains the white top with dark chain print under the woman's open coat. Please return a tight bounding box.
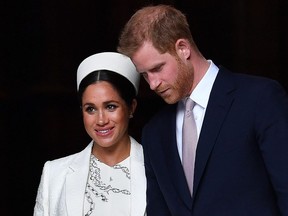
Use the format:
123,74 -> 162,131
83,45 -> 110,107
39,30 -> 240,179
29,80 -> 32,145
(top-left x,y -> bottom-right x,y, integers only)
84,154 -> 131,216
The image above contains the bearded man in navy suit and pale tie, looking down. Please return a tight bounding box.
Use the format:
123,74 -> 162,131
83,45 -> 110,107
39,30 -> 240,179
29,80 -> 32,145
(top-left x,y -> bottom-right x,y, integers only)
118,5 -> 288,216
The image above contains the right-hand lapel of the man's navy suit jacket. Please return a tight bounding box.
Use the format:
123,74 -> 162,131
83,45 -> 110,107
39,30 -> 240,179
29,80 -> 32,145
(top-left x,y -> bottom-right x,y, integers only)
193,68 -> 235,196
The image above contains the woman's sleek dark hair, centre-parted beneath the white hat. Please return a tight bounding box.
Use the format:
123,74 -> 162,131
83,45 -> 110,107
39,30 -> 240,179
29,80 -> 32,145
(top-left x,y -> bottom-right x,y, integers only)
78,70 -> 136,107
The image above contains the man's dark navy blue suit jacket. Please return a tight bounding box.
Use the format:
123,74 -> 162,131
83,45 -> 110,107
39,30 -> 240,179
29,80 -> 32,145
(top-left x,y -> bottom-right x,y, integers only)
142,68 -> 288,216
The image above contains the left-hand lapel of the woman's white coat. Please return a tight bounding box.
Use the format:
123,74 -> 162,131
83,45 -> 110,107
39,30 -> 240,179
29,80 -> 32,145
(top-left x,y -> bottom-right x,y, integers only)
66,141 -> 93,216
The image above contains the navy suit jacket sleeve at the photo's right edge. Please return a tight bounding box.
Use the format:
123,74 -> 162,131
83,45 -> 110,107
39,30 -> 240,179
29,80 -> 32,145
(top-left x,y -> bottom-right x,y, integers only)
256,80 -> 288,215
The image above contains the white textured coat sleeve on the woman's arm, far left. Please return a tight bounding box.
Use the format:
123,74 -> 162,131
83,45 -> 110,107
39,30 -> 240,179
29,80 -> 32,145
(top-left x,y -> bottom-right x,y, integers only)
33,161 -> 50,216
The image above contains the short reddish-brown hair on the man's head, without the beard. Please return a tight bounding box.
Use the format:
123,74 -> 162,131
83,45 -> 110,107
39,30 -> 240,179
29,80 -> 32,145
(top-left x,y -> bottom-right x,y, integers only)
117,5 -> 197,57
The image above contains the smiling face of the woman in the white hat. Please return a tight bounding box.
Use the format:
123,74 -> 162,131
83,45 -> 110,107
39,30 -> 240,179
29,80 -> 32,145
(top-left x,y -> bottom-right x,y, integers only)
82,81 -> 136,149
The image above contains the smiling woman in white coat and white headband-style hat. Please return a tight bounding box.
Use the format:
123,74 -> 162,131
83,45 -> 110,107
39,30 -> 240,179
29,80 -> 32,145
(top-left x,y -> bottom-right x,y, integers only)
34,52 -> 146,216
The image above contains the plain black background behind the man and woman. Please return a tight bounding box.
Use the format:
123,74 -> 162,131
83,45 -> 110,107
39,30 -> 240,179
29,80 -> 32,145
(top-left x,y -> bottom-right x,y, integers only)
0,0 -> 288,216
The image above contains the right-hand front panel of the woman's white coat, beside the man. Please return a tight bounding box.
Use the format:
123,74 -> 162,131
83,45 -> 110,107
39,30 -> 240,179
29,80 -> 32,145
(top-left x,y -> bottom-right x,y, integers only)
130,137 -> 146,216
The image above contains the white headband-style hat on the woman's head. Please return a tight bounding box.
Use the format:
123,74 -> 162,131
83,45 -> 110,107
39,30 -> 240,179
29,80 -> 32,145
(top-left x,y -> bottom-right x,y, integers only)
77,52 -> 140,94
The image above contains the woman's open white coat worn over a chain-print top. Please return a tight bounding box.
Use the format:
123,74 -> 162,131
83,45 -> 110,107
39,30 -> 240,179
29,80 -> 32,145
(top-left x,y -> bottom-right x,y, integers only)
34,137 -> 146,216
